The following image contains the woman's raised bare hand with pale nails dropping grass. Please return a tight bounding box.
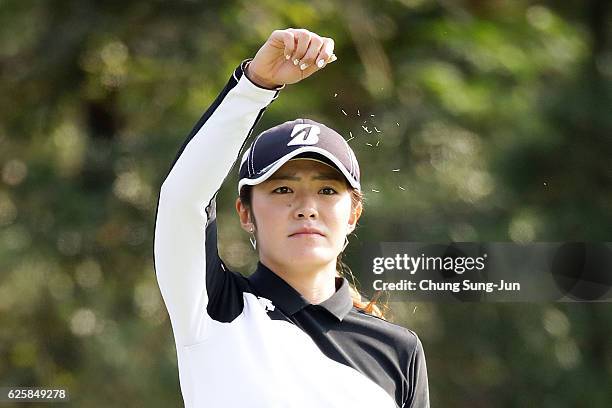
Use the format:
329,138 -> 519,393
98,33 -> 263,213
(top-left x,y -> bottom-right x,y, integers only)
246,28 -> 336,88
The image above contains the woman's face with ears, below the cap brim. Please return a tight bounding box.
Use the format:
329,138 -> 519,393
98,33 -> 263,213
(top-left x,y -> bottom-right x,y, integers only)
237,159 -> 361,271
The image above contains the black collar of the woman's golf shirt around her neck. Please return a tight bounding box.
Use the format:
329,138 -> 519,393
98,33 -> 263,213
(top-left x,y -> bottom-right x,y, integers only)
249,262 -> 353,321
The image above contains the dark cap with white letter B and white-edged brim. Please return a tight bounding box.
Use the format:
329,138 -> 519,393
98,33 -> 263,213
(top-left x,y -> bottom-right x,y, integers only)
238,119 -> 361,194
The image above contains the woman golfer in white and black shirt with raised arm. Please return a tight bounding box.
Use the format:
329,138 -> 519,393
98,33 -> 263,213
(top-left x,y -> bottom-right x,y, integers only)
155,29 -> 429,408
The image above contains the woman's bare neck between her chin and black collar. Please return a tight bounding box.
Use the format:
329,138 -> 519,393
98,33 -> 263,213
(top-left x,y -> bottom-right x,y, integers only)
261,260 -> 336,305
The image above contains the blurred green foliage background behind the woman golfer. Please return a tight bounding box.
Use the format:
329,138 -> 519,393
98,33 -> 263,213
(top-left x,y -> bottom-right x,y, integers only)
0,0 -> 612,407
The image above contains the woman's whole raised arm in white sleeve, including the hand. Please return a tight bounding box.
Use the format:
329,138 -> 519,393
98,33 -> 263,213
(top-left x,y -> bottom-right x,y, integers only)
154,29 -> 333,345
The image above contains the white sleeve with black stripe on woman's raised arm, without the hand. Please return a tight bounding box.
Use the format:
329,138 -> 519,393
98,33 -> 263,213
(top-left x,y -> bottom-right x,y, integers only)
154,63 -> 277,344
